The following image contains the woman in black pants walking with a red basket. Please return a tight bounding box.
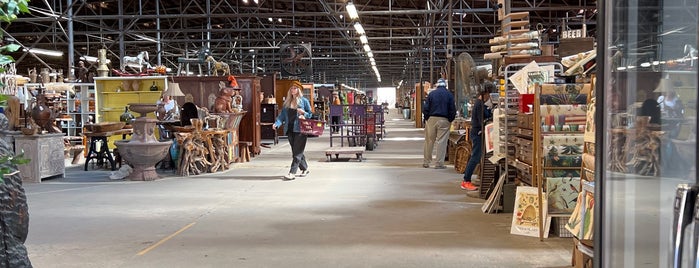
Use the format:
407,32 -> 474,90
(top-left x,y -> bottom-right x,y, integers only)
272,81 -> 312,180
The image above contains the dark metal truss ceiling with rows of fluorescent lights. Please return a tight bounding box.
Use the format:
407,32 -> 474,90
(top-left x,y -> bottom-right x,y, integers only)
4,0 -> 596,87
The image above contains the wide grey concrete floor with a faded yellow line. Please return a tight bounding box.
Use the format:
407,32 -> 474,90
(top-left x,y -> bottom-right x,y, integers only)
25,110 -> 572,268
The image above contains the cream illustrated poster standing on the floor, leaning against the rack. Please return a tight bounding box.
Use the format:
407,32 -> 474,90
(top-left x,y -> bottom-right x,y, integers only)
510,186 -> 547,237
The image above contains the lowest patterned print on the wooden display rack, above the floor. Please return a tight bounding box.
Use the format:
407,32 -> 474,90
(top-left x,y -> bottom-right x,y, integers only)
546,177 -> 580,215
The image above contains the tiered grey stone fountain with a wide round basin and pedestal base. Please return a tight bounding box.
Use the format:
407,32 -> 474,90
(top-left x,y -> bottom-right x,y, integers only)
114,103 -> 172,181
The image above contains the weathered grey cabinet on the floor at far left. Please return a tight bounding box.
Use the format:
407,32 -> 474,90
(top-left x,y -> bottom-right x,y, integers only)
14,133 -> 65,182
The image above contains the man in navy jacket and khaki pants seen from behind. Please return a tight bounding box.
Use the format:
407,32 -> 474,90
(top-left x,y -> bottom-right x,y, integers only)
422,78 -> 456,169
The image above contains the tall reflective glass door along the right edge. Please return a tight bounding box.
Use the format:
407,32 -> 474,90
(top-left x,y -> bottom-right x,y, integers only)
594,0 -> 699,268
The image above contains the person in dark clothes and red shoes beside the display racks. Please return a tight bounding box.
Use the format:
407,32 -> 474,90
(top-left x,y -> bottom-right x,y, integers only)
461,82 -> 495,191
